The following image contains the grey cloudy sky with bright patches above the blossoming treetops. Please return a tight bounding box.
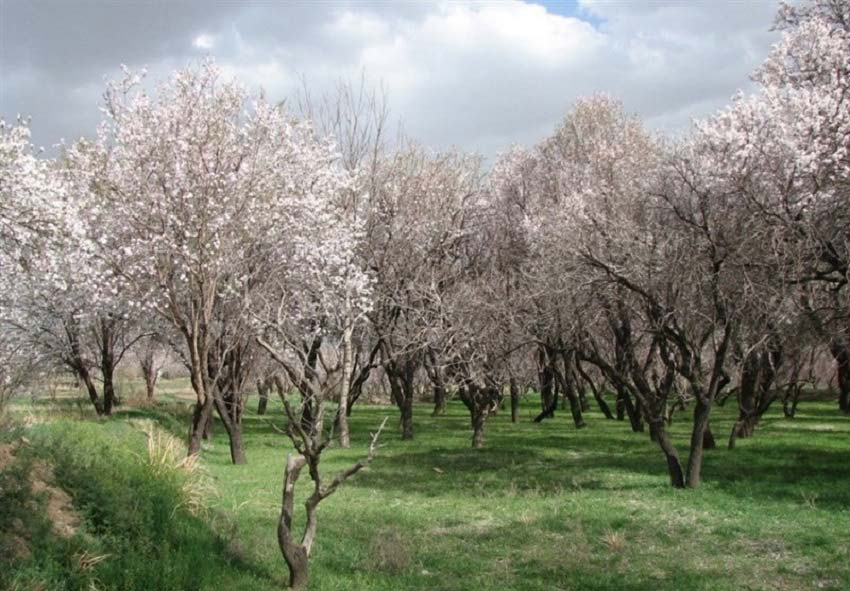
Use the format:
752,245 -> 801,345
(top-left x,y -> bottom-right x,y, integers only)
0,0 -> 776,156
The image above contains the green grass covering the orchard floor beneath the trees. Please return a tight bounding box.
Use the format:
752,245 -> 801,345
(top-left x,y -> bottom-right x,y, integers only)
1,388 -> 850,591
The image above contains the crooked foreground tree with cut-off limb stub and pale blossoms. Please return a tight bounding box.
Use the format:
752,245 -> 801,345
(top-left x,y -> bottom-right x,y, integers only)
242,131 -> 378,589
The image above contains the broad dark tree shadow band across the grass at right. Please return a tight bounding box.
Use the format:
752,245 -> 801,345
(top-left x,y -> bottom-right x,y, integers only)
336,406 -> 850,509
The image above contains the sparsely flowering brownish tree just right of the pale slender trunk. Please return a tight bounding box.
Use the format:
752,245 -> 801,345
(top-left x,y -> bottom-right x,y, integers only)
364,145 -> 481,439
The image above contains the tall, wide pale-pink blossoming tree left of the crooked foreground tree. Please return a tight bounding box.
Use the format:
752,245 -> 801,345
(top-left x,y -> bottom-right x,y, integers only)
73,60 -> 352,461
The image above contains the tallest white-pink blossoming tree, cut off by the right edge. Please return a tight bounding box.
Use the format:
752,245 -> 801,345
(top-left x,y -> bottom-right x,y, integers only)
698,0 -> 850,412
